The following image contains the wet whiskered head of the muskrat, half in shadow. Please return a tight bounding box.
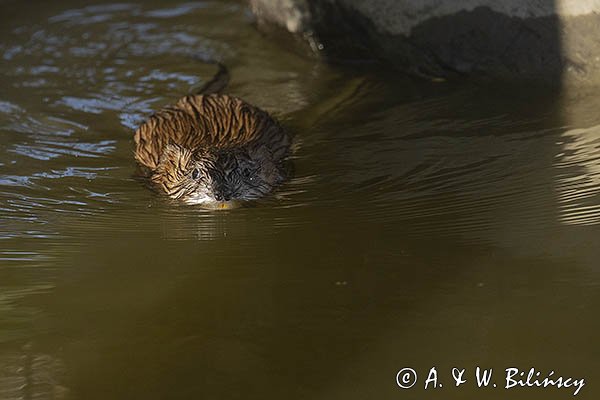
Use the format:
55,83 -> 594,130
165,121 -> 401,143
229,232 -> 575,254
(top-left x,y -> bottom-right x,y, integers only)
151,144 -> 282,208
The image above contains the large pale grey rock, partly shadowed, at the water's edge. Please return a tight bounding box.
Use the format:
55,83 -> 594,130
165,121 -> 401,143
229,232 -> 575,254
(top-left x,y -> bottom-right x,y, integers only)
250,0 -> 600,83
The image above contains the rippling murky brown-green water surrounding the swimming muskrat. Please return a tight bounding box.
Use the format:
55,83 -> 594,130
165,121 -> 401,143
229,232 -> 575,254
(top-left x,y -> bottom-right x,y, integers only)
0,0 -> 600,400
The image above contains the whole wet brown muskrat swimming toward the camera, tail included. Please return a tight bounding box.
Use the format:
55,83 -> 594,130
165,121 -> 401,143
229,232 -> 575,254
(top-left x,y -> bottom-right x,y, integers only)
134,63 -> 290,208
